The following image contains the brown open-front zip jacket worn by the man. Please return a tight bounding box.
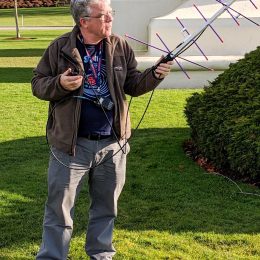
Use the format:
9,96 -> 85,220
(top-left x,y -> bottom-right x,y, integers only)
32,26 -> 164,155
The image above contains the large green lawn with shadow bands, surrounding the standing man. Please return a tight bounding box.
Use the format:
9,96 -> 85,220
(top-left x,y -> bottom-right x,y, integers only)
0,31 -> 260,260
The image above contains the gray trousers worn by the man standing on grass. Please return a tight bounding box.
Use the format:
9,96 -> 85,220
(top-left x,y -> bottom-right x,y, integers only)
36,138 -> 130,260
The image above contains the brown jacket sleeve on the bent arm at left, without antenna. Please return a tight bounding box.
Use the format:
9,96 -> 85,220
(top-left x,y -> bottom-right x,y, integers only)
31,45 -> 71,101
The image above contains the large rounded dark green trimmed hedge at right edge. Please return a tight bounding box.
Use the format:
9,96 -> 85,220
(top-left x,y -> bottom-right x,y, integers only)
184,47 -> 260,181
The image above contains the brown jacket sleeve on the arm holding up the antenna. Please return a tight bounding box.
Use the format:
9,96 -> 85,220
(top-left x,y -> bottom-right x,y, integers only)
124,42 -> 162,97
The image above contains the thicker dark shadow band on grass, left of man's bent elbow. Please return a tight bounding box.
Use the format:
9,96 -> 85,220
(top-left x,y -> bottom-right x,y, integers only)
0,68 -> 34,83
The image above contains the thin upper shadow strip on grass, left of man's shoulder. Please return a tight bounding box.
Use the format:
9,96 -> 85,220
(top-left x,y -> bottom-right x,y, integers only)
0,49 -> 44,57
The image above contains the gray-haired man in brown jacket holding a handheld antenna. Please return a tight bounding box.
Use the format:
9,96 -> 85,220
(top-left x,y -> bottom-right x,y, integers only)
32,0 -> 172,259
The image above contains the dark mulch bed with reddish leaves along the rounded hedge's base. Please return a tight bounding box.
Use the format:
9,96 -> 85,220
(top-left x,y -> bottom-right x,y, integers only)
183,140 -> 260,188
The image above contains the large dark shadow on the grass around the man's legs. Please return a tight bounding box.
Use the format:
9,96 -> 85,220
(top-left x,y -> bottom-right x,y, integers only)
0,128 -> 260,250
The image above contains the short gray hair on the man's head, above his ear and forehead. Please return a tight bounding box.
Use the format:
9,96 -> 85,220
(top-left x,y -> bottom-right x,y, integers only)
70,0 -> 111,26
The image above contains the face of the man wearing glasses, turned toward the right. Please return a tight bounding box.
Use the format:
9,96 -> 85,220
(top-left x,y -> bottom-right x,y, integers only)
82,2 -> 113,40
